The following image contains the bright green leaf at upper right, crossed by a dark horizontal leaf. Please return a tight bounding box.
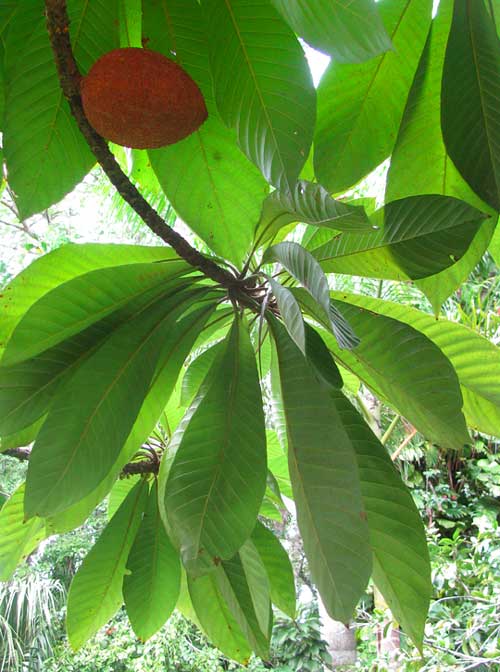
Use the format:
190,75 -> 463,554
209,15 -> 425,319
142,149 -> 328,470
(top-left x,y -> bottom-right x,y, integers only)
386,0 -> 495,313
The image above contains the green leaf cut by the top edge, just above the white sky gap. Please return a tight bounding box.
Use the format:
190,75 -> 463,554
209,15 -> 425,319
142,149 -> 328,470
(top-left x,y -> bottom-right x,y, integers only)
273,0 -> 391,63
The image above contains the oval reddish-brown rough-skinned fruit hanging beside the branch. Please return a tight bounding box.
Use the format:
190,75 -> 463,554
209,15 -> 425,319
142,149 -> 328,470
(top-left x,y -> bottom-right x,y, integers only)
81,47 -> 208,149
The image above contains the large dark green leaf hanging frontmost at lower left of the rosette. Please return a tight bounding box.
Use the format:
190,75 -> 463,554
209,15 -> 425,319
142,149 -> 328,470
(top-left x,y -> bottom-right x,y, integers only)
25,293 -> 207,517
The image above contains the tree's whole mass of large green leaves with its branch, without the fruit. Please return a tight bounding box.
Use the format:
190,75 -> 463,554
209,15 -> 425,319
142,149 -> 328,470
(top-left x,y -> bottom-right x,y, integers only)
0,0 -> 500,661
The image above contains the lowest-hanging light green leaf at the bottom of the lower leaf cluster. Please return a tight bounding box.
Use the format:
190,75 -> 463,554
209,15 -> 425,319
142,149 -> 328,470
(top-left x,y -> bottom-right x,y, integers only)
188,572 -> 251,664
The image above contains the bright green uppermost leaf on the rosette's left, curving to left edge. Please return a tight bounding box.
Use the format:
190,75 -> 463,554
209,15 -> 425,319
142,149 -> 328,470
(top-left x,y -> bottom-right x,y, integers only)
0,243 -> 179,351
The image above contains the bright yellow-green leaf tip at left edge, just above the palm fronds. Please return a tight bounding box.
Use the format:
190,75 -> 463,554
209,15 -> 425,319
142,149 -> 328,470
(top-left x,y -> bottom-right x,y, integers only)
0,483 -> 47,581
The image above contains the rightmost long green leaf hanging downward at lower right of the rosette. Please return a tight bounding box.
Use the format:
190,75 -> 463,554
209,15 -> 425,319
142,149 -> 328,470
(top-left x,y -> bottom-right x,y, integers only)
331,391 -> 432,648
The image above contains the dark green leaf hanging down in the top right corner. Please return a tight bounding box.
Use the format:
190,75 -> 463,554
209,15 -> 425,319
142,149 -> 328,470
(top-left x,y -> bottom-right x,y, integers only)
441,0 -> 500,211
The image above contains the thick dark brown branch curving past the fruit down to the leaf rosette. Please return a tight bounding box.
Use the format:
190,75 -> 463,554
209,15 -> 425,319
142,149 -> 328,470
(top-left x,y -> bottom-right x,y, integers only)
45,0 -> 242,289
